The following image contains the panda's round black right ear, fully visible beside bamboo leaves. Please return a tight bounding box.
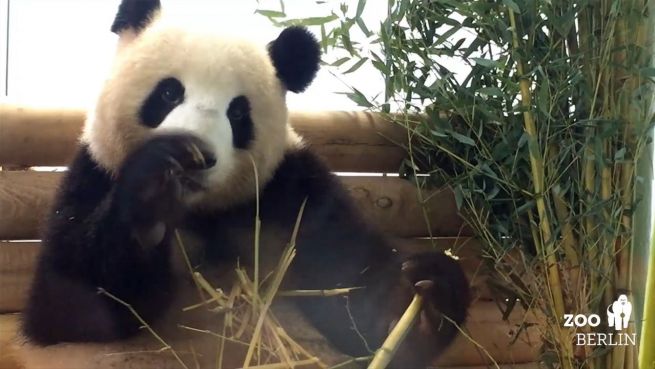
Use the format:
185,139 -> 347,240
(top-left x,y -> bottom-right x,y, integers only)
268,26 -> 321,92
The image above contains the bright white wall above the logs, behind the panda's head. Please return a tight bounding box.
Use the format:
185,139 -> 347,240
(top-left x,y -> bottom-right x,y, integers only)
0,0 -> 386,110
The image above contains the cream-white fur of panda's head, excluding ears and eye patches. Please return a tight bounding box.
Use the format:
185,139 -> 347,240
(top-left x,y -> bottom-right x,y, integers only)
82,12 -> 300,207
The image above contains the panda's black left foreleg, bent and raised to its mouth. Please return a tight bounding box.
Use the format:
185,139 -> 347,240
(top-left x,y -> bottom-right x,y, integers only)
23,135 -> 215,345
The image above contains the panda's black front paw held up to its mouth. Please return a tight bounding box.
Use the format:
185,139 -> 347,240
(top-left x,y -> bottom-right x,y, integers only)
116,133 -> 216,226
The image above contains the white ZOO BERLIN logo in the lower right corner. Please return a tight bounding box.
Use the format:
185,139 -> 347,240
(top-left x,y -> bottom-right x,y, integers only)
564,295 -> 637,346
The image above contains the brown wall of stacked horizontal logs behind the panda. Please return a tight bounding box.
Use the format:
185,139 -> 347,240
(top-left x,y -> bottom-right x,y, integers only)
0,104 -> 541,366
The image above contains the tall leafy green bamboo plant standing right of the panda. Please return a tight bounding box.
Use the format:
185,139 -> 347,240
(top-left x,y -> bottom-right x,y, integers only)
259,0 -> 655,369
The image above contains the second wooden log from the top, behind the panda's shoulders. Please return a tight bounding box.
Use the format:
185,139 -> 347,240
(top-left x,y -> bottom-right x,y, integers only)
0,171 -> 470,240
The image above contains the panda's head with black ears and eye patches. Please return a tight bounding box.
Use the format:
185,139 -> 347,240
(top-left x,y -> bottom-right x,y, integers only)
82,0 -> 320,206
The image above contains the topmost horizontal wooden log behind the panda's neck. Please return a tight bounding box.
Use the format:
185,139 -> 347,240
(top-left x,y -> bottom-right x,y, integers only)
0,104 -> 407,172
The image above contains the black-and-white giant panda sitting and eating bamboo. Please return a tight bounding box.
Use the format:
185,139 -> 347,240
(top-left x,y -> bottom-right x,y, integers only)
20,0 -> 469,369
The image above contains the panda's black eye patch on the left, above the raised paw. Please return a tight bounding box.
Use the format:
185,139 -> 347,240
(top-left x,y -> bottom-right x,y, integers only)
139,77 -> 184,128
